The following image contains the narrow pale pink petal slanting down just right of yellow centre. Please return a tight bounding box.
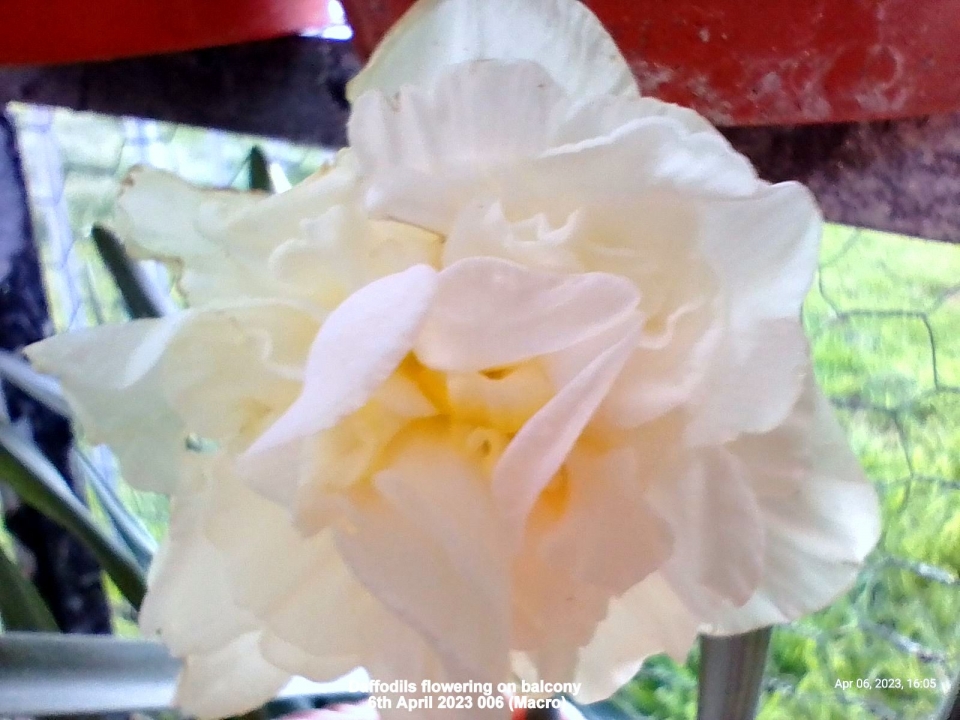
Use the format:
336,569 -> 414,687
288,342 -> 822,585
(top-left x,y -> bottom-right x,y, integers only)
493,318 -> 639,533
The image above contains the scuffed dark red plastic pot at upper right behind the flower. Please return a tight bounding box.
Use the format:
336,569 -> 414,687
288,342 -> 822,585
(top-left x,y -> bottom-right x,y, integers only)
344,0 -> 960,125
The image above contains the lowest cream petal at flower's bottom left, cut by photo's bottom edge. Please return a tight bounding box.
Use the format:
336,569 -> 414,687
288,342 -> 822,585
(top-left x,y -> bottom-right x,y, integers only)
174,632 -> 290,720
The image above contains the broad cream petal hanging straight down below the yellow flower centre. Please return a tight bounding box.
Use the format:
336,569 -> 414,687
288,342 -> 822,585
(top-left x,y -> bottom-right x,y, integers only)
339,428 -> 510,680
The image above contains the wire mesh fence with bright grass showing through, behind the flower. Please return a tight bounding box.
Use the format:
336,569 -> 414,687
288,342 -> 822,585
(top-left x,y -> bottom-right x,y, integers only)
7,106 -> 960,720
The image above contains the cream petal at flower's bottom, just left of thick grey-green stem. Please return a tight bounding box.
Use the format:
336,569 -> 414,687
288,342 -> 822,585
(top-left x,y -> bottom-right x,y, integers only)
575,573 -> 699,703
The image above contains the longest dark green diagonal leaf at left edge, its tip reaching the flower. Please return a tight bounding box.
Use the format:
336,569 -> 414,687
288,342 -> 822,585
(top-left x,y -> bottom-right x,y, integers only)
0,425 -> 146,609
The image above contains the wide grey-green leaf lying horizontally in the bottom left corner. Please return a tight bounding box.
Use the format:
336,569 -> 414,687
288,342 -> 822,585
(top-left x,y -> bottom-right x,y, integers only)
0,633 -> 180,717
